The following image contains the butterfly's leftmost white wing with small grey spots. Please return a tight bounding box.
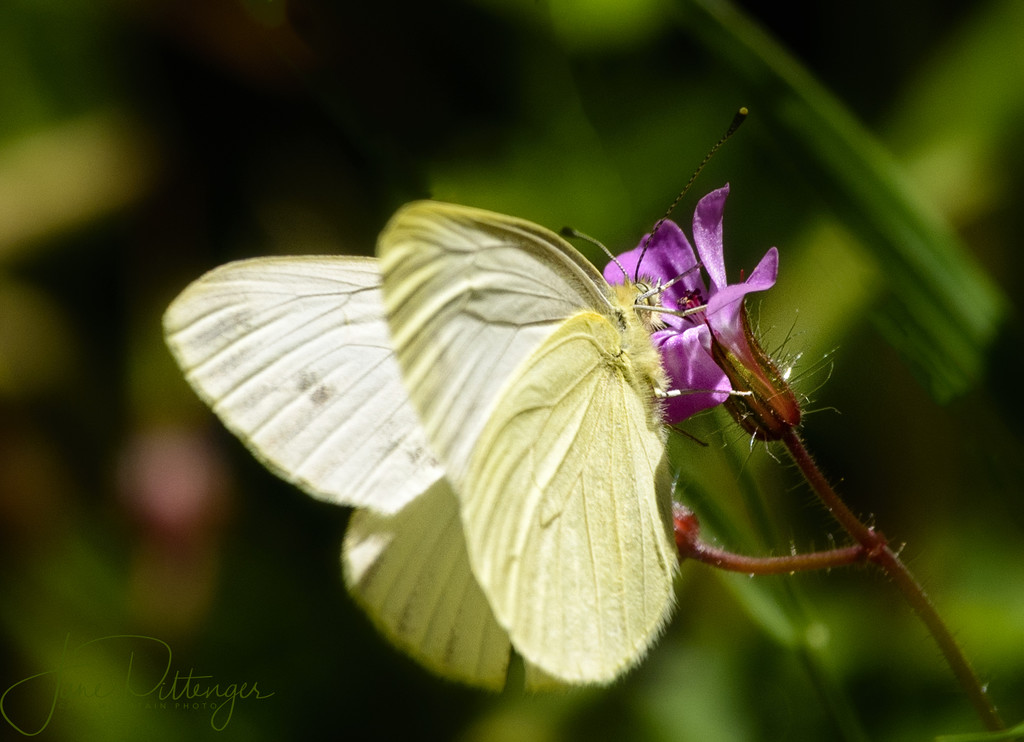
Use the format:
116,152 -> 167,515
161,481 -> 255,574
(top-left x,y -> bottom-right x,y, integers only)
164,257 -> 443,513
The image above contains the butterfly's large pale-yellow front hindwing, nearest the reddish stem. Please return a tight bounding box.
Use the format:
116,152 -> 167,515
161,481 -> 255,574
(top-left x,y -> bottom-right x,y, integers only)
461,312 -> 678,683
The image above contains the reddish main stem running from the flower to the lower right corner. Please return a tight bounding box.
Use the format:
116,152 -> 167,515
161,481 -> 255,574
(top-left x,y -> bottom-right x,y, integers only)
781,429 -> 1006,731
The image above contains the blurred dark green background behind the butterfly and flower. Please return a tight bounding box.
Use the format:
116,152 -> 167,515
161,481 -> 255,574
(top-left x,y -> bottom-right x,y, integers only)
0,0 -> 1024,742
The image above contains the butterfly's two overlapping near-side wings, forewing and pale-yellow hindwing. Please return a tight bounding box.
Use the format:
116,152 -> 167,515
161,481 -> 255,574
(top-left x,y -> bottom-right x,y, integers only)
379,203 -> 676,683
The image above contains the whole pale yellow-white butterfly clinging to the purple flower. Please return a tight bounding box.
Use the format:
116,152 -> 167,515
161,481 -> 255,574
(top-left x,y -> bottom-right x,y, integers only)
164,202 -> 678,688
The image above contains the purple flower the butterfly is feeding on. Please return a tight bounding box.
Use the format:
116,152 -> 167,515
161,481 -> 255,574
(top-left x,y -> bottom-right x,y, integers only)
604,184 -> 778,424
